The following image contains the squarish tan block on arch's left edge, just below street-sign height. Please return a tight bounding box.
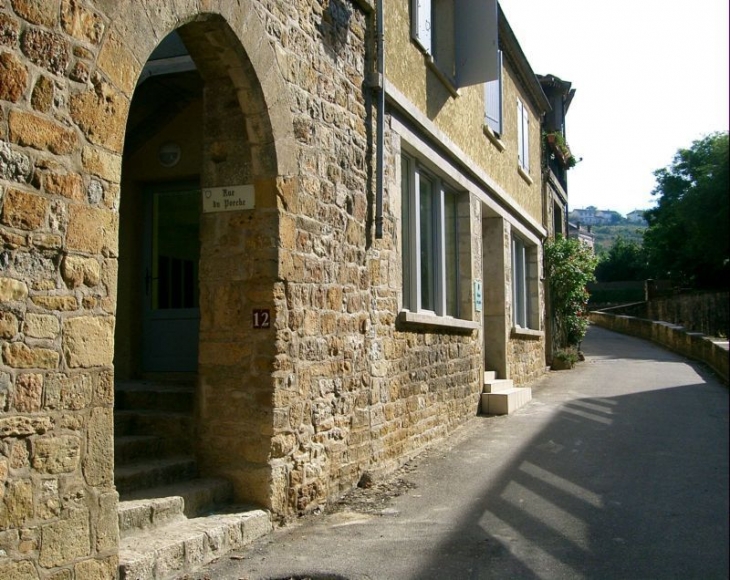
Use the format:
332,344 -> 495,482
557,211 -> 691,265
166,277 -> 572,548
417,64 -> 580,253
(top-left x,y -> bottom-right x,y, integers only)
66,205 -> 119,256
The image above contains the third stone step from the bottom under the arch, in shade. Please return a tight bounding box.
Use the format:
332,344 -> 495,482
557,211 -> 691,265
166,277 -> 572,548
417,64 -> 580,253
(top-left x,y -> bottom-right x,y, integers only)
114,456 -> 198,494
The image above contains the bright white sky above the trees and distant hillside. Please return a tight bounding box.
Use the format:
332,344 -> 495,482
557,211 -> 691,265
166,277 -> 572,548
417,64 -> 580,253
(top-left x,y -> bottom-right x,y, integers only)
500,0 -> 730,215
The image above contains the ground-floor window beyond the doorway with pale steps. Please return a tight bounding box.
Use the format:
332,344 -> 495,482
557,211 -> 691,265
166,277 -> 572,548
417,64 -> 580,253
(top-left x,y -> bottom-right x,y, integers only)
512,236 -> 539,330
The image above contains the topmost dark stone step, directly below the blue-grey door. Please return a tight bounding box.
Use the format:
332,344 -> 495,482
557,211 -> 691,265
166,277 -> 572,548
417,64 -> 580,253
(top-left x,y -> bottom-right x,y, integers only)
114,381 -> 195,414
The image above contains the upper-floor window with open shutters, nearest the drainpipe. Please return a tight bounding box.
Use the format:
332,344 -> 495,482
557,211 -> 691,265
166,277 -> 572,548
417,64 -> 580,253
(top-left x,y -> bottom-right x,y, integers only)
411,0 -> 498,87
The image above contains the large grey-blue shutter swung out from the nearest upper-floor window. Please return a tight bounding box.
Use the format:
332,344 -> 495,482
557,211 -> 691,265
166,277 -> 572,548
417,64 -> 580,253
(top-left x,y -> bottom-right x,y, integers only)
456,0 -> 499,87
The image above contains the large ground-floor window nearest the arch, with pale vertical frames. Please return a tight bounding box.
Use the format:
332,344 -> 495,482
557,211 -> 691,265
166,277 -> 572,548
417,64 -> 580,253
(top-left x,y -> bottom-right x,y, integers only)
401,155 -> 468,318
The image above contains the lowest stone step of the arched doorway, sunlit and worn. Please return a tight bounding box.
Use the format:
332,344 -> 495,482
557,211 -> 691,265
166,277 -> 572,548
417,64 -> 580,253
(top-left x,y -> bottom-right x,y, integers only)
119,508 -> 273,580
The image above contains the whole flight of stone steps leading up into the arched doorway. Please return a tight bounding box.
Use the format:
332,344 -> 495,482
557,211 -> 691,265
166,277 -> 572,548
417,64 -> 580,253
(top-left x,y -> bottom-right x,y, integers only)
114,381 -> 272,580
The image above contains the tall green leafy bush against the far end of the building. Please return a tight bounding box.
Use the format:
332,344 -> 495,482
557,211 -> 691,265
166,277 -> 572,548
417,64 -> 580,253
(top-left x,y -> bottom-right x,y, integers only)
545,236 -> 597,348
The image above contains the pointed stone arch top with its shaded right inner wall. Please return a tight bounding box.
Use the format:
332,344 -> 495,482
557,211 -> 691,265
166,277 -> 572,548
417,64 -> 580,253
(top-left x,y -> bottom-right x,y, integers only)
98,2 -> 296,507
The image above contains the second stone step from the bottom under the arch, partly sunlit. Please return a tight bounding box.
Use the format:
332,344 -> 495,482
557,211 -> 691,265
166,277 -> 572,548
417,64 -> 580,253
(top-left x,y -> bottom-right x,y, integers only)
118,478 -> 233,537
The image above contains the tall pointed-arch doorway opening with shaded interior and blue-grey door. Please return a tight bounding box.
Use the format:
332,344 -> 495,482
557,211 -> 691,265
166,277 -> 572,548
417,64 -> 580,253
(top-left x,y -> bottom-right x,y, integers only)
114,7 -> 289,544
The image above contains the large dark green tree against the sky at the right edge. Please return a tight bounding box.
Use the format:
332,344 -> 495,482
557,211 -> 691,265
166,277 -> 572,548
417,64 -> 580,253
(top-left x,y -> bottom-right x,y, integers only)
644,131 -> 730,289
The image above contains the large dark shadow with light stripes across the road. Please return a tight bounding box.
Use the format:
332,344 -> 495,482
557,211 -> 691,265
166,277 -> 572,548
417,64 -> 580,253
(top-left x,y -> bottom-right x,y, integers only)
412,374 -> 729,580
